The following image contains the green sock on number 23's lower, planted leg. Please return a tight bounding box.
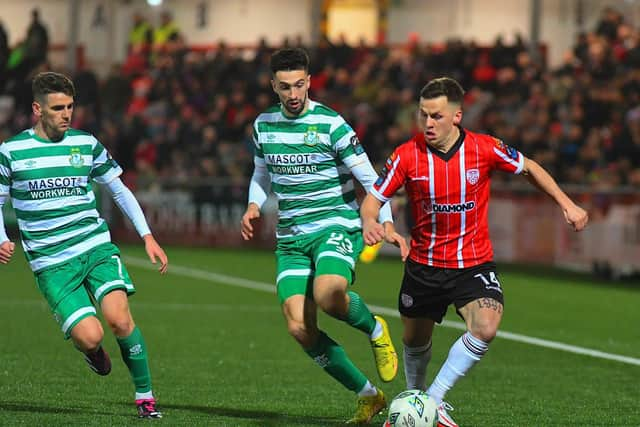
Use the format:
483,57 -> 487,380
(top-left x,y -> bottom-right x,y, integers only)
305,332 -> 368,393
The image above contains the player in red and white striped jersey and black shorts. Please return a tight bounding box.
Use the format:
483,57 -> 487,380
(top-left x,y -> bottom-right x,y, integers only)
361,77 -> 588,427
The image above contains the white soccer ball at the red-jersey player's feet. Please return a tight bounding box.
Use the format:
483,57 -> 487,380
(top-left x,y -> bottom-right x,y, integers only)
384,390 -> 438,427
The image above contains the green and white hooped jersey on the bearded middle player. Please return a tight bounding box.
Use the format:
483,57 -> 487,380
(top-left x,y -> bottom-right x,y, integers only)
253,101 -> 369,239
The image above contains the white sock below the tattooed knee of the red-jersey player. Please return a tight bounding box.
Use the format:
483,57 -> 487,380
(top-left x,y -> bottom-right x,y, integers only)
427,332 -> 489,404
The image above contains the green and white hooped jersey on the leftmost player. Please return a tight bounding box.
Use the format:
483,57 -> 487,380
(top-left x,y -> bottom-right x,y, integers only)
0,129 -> 122,272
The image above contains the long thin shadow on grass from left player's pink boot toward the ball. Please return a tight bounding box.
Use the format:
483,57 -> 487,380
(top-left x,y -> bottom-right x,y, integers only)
143,402 -> 344,427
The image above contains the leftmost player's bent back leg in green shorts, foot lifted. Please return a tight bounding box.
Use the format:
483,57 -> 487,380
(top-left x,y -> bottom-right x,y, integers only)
35,255 -> 111,375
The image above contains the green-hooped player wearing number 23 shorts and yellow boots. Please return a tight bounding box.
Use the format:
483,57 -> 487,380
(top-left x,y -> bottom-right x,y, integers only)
241,49 -> 408,424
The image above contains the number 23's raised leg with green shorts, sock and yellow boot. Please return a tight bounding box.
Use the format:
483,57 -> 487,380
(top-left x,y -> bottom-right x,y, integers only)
313,229 -> 398,382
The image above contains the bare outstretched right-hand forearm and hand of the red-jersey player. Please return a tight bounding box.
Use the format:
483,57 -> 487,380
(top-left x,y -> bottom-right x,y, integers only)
521,157 -> 589,231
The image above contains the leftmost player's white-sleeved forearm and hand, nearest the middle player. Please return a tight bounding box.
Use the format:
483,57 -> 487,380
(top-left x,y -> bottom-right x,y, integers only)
104,178 -> 169,274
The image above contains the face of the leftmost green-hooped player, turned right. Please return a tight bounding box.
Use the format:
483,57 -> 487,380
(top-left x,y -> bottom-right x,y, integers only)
33,93 -> 73,141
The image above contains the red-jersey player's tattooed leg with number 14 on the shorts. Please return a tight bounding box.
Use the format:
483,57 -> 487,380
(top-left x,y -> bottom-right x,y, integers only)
427,263 -> 504,426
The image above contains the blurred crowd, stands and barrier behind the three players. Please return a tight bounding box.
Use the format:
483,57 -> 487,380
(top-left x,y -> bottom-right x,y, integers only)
0,0 -> 640,280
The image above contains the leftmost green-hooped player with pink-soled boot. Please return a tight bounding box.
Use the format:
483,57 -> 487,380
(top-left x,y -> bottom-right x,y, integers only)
0,72 -> 168,418
